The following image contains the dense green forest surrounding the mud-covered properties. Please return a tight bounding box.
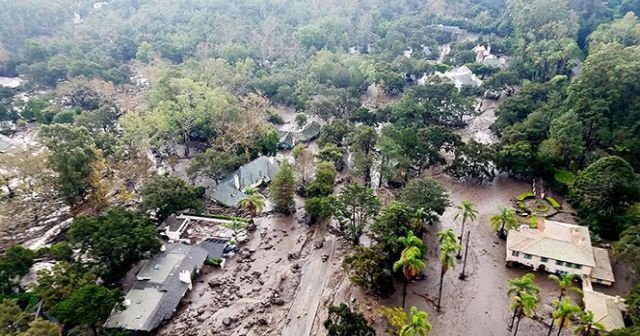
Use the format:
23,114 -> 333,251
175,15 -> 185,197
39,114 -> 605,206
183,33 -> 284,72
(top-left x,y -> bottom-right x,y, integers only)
0,0 -> 640,336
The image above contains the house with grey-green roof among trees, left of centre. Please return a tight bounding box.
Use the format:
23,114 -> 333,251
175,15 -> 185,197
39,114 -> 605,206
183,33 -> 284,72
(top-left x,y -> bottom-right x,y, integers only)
209,156 -> 278,207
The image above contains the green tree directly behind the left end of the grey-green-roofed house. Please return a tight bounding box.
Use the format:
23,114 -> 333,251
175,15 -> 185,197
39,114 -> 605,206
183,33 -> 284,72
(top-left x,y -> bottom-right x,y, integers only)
187,147 -> 243,183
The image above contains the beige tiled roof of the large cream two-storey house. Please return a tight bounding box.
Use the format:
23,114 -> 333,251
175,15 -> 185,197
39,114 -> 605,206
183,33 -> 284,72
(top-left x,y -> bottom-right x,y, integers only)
507,220 -> 596,267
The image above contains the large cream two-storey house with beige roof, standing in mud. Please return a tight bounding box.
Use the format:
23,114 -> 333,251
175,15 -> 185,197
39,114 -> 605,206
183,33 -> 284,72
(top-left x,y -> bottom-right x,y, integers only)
505,220 -> 614,285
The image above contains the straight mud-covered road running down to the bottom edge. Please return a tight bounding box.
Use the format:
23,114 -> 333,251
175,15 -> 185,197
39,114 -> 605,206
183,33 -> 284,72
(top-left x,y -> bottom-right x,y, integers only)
281,236 -> 335,336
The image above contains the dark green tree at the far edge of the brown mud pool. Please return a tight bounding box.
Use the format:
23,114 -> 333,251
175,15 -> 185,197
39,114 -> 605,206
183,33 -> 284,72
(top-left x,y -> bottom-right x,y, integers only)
445,139 -> 496,184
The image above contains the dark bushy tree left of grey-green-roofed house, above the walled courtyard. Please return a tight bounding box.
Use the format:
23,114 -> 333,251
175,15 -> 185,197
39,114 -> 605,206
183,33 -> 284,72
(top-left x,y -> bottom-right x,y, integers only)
140,175 -> 203,220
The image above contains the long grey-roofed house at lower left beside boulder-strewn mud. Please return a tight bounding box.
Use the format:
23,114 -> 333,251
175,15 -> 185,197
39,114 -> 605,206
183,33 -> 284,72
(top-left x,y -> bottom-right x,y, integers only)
104,244 -> 207,332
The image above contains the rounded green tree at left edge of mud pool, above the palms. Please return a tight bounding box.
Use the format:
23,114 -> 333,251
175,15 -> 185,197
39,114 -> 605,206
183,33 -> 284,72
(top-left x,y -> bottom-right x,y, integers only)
398,177 -> 451,222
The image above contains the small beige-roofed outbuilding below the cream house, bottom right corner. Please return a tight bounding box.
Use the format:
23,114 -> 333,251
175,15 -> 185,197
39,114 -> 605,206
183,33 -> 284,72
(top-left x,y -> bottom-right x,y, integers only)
582,290 -> 626,331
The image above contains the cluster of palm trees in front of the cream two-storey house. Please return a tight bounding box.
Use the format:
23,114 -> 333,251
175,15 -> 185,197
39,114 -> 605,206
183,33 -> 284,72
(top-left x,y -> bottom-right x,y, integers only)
507,273 -> 605,336
